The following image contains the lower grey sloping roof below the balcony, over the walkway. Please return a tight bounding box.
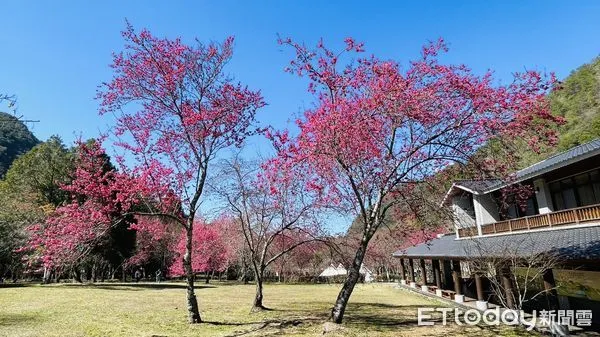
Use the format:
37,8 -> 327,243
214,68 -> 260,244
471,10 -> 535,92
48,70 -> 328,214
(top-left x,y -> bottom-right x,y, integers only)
393,224 -> 600,260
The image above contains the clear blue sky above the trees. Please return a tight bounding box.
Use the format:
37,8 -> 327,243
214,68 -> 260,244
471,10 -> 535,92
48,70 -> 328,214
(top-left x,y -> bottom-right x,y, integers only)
0,1 -> 600,148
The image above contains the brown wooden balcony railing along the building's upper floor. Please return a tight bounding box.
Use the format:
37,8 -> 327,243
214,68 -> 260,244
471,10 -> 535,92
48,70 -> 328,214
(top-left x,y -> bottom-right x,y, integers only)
476,204 -> 600,237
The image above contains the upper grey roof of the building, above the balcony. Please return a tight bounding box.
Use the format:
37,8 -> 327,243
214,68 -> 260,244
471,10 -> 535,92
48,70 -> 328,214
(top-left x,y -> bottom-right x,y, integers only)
442,138 -> 600,205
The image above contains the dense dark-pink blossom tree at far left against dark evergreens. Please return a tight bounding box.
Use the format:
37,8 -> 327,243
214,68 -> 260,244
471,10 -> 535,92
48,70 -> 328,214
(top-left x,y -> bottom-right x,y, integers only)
23,140 -> 136,280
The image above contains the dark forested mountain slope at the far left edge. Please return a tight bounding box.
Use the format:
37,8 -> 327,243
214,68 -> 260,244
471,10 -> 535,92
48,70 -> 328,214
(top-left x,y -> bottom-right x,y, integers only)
0,112 -> 39,178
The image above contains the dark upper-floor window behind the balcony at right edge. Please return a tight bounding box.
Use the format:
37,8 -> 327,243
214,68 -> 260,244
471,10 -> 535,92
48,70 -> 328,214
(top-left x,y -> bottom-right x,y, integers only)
550,170 -> 600,211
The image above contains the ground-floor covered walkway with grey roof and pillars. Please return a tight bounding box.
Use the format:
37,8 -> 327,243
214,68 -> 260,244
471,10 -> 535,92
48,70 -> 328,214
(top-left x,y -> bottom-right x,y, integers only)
393,224 -> 600,310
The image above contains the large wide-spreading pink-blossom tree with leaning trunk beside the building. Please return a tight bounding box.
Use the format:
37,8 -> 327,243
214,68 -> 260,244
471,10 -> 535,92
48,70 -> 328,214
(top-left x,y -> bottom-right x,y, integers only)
272,38 -> 559,323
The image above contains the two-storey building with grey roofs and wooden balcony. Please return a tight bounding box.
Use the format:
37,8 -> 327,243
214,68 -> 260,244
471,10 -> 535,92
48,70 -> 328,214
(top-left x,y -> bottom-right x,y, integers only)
394,139 -> 600,324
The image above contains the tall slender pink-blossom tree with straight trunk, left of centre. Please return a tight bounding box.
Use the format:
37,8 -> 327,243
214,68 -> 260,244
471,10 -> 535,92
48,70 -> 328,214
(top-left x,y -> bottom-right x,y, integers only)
98,24 -> 264,323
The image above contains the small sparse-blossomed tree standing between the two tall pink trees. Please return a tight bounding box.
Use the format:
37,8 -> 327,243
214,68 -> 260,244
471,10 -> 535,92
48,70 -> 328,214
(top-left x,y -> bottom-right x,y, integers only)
217,156 -> 321,311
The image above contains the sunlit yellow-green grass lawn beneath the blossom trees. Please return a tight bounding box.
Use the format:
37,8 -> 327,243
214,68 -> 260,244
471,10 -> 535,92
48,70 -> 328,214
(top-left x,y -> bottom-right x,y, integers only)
0,283 -> 528,337
